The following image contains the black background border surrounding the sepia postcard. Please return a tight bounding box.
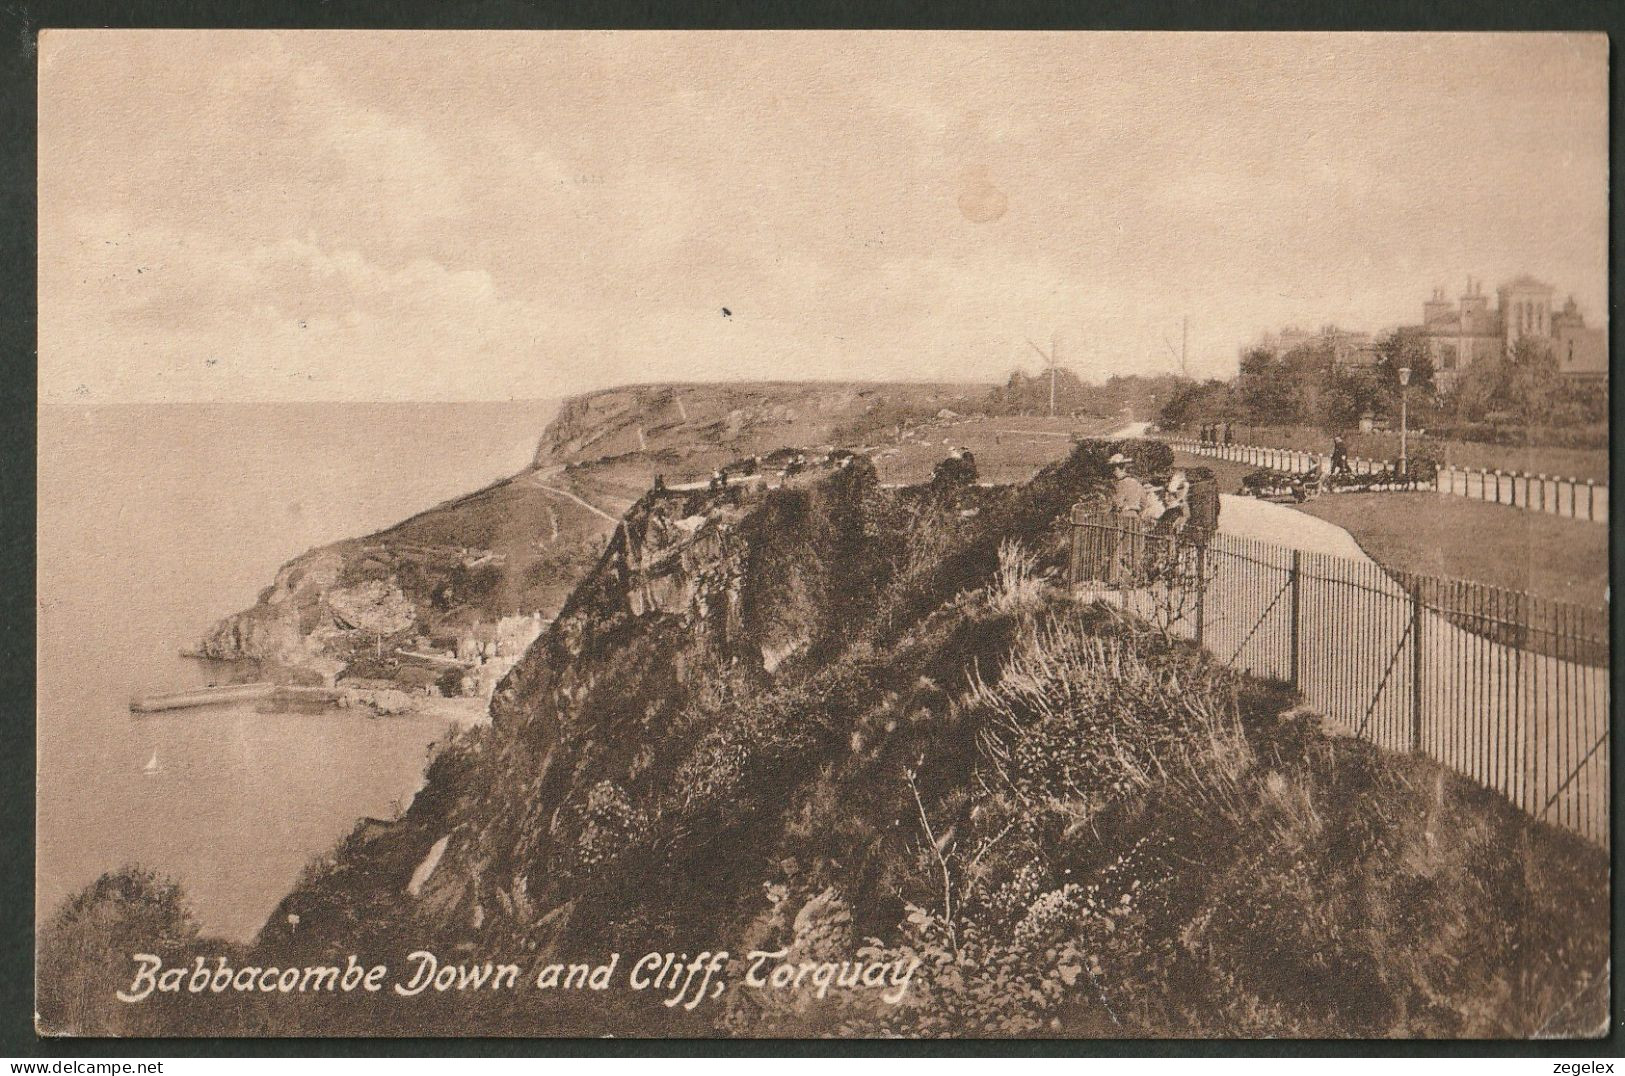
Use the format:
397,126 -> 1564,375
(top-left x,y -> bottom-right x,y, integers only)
0,0 -> 1625,1071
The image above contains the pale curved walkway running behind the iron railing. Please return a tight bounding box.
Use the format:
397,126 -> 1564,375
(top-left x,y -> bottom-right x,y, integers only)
1098,494 -> 1610,847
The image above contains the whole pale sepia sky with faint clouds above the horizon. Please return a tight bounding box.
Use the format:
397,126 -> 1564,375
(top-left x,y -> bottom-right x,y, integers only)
39,29 -> 1607,403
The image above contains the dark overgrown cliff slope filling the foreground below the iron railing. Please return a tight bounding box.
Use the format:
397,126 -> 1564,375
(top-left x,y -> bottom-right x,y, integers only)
41,442 -> 1609,1037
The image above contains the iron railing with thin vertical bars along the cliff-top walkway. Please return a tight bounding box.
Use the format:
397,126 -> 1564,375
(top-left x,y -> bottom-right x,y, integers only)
1071,505 -> 1609,847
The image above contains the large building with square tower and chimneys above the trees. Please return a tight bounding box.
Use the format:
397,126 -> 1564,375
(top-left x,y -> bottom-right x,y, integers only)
1412,276 -> 1609,388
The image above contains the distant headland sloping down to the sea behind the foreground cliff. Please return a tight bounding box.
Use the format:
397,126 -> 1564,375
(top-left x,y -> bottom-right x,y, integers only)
195,382 -> 982,678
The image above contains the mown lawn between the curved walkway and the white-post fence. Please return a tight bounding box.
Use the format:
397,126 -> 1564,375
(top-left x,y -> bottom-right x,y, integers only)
1300,492 -> 1609,606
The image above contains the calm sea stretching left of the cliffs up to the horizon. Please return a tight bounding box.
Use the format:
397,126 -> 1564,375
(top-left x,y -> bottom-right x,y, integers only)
36,401 -> 557,941
